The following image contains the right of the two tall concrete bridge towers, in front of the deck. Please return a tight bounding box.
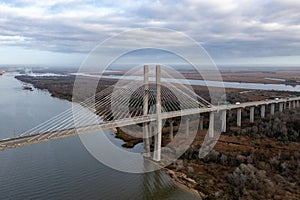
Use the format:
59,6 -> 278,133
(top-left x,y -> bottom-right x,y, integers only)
153,65 -> 162,161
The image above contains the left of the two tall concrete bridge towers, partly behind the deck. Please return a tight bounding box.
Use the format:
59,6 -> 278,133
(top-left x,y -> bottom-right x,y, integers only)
143,65 -> 150,157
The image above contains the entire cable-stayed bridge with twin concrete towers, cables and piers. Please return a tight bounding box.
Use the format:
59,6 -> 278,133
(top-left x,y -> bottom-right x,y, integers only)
0,66 -> 300,161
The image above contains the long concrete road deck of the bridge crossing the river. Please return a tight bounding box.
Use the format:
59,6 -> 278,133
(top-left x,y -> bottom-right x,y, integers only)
0,97 -> 300,151
